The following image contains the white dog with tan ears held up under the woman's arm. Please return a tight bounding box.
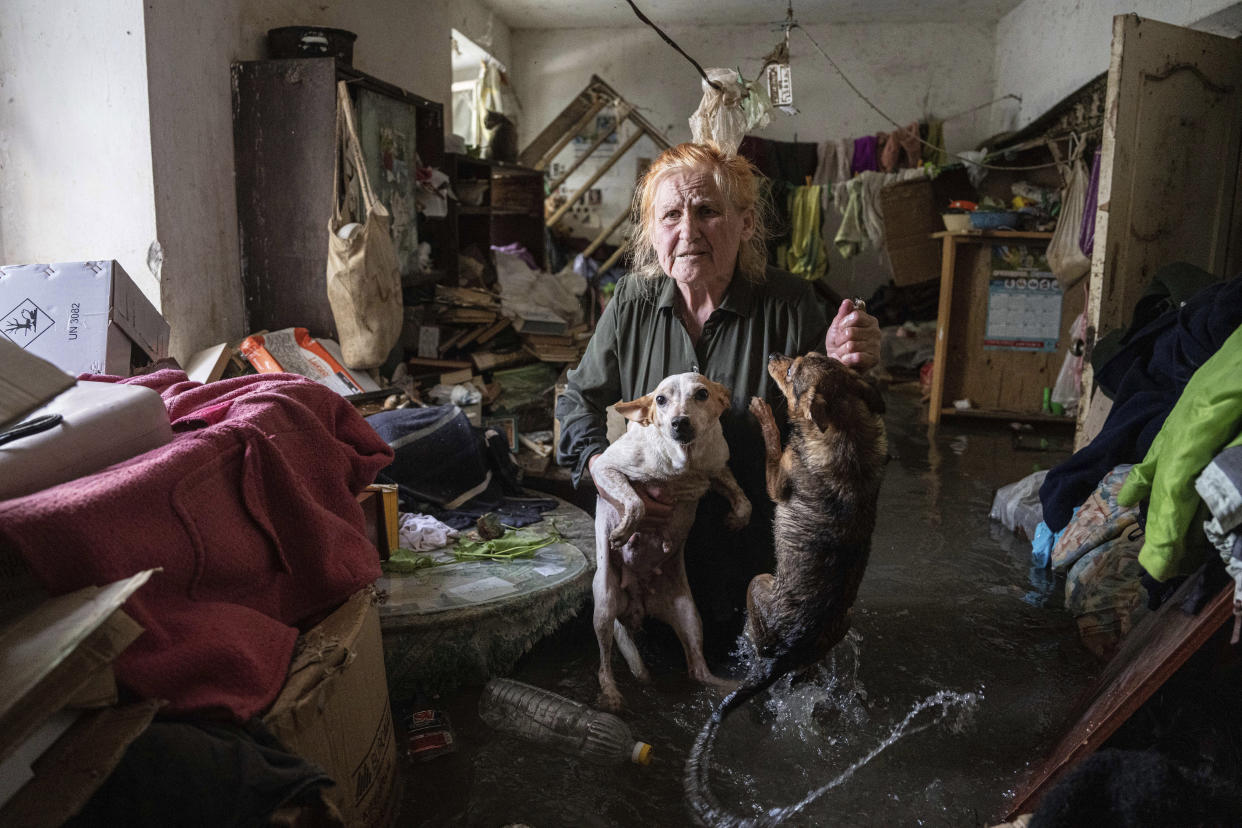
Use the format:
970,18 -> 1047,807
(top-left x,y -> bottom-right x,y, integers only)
591,374 -> 750,711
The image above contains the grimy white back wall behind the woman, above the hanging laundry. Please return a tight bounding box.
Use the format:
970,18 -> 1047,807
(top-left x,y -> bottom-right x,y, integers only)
512,22 -> 995,301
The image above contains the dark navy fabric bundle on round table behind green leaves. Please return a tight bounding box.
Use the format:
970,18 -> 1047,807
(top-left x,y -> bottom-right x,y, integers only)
366,406 -> 556,529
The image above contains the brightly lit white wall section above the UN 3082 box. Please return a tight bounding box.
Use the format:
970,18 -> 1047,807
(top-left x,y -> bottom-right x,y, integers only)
0,0 -> 159,307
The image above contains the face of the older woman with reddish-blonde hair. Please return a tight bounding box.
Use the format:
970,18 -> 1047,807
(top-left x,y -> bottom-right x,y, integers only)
651,169 -> 755,288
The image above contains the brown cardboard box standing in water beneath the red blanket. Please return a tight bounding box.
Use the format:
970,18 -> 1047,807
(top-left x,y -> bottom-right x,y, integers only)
263,587 -> 397,828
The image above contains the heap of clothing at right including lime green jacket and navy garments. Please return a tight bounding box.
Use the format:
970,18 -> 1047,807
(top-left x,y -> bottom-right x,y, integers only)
1040,269 -> 1242,655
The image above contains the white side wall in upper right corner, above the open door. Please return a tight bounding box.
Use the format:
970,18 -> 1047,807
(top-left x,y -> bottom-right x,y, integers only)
992,0 -> 1240,132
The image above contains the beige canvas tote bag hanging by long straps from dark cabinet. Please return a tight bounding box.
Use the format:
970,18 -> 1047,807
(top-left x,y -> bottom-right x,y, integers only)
328,82 -> 404,369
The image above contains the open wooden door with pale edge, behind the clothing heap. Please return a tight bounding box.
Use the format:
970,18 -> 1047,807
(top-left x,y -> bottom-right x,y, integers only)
1074,15 -> 1242,448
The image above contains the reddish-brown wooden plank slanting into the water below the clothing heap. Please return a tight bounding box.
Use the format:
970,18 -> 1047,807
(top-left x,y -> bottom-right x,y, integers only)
1007,577 -> 1233,819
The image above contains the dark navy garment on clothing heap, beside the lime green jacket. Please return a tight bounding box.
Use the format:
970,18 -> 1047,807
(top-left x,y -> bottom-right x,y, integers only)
1040,276 -> 1242,533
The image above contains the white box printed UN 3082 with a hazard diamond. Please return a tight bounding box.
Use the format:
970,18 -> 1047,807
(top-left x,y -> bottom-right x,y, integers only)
0,261 -> 169,376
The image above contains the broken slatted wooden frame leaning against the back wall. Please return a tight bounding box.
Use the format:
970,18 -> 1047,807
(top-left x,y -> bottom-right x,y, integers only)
518,74 -> 671,273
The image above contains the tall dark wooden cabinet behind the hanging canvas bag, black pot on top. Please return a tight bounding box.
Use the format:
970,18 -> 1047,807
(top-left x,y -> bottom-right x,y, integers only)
232,57 -> 456,339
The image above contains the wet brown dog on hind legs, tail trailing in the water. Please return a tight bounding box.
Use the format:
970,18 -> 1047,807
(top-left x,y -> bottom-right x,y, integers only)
684,354 -> 888,826
